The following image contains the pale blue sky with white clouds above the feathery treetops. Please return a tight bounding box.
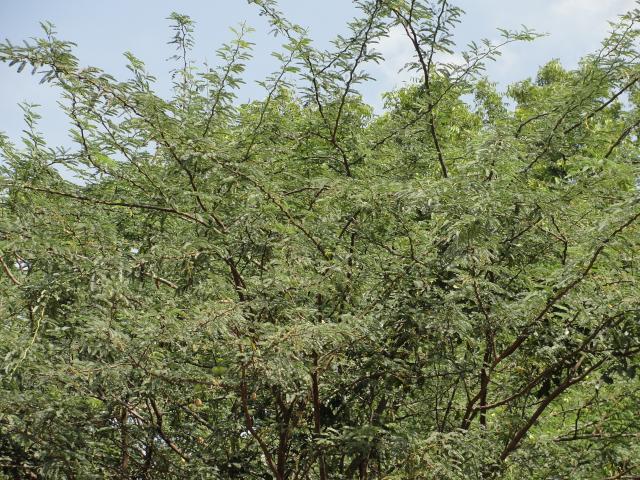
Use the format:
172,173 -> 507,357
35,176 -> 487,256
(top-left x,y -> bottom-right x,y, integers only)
0,0 -> 637,145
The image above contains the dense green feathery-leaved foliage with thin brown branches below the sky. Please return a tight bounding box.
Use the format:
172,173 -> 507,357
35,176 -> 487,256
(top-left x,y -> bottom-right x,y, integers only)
0,0 -> 640,480
